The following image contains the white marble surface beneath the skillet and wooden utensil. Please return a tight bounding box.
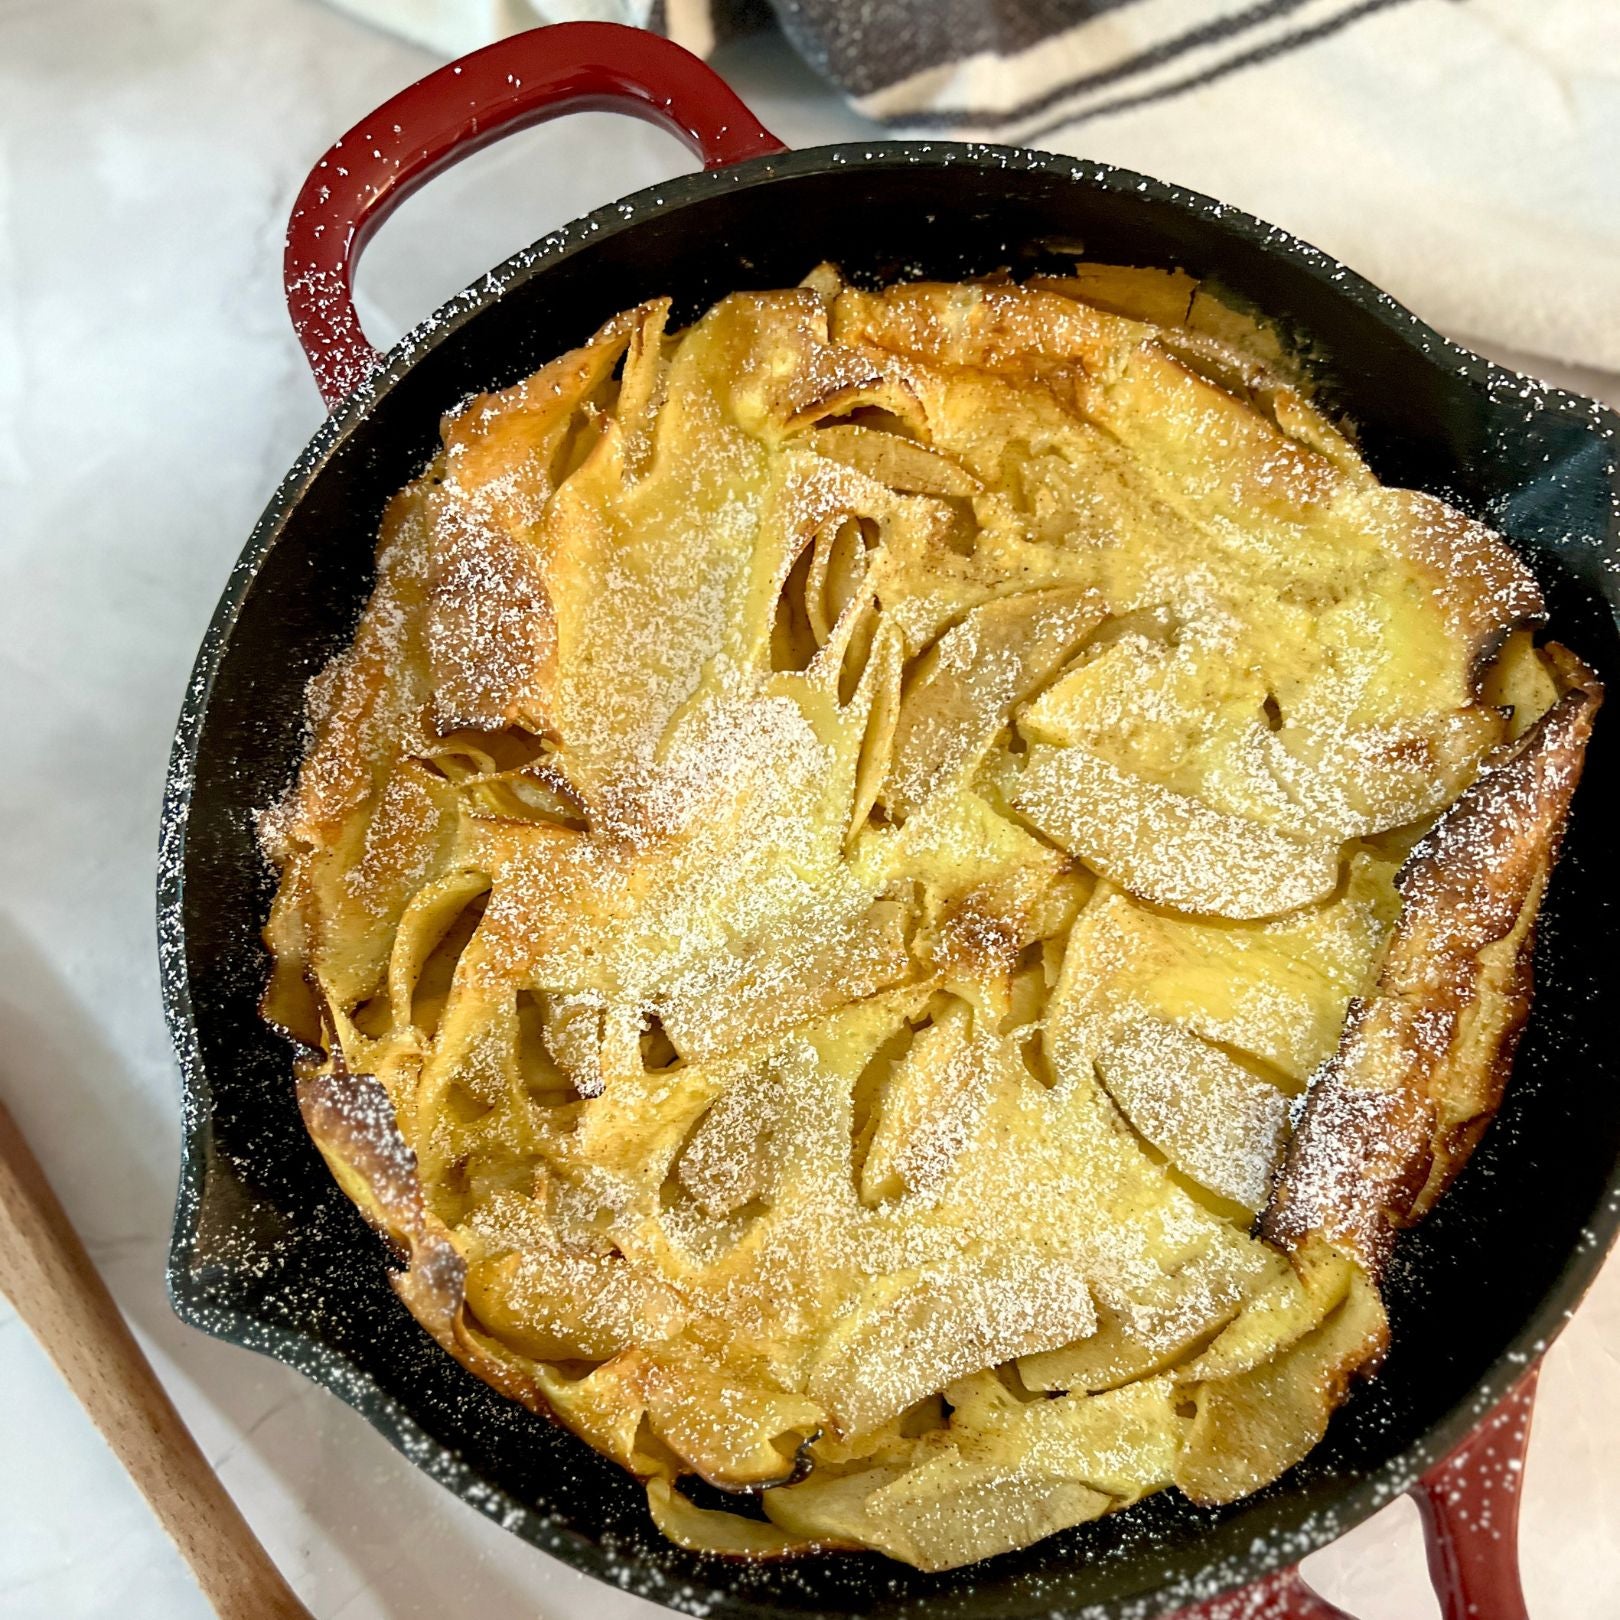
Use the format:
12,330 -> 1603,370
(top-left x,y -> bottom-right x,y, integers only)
0,0 -> 1620,1620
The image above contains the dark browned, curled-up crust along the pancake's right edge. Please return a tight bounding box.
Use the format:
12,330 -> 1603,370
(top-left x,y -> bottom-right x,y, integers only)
1260,645 -> 1602,1278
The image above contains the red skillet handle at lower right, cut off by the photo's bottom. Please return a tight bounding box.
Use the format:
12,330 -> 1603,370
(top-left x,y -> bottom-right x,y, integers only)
1173,1367 -> 1536,1620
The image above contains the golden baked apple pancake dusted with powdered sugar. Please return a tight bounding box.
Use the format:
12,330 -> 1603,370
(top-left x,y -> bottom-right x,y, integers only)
262,266 -> 1599,1570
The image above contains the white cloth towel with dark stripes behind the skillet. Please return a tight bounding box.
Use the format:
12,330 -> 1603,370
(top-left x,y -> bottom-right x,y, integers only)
322,0 -> 1620,371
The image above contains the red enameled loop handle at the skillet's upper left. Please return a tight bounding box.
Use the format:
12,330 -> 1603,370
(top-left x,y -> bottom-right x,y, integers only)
284,23 -> 786,408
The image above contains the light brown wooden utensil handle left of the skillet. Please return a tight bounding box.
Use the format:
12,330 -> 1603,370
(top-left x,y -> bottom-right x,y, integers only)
0,1106 -> 309,1620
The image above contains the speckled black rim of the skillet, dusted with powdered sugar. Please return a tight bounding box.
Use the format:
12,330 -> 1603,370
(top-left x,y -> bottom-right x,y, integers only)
157,141 -> 1620,1620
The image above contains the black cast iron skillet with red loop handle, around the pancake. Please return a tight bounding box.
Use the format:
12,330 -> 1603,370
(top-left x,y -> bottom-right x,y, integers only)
159,24 -> 1620,1620
